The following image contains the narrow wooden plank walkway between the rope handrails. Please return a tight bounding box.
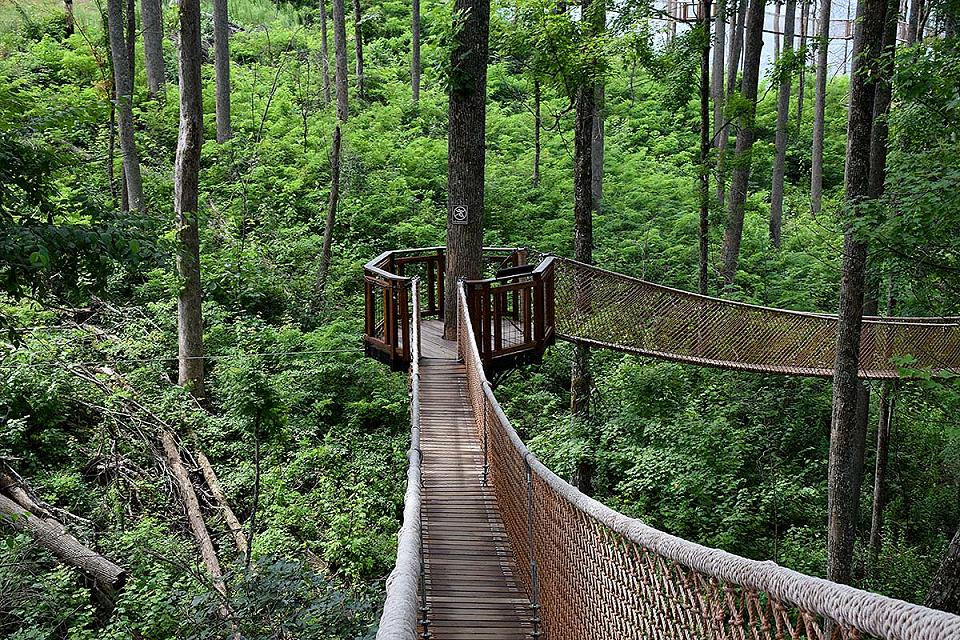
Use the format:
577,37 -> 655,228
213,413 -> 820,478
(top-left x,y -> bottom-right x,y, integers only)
420,321 -> 532,640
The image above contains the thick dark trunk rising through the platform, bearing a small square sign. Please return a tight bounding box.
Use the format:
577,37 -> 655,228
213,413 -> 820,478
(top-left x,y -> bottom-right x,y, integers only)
443,0 -> 490,340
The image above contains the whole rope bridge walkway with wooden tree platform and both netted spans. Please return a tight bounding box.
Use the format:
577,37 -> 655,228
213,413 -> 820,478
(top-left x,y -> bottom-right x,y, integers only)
364,247 -> 960,640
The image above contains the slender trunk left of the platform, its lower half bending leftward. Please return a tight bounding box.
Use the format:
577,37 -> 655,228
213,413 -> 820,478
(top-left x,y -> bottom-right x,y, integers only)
314,0 -> 350,303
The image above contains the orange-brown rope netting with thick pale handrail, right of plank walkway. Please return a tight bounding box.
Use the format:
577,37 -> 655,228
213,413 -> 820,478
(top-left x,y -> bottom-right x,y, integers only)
458,289 -> 960,640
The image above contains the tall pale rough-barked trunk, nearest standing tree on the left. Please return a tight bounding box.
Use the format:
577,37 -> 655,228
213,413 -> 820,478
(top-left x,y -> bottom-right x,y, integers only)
173,0 -> 204,398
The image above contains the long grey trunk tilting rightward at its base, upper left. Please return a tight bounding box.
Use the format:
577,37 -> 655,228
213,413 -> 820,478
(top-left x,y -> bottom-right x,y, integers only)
107,0 -> 143,211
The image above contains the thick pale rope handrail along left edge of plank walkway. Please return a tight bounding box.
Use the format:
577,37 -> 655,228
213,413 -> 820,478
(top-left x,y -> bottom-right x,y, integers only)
377,278 -> 423,640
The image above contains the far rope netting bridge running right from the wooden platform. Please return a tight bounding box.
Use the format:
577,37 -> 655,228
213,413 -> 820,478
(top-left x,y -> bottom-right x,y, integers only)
556,259 -> 960,378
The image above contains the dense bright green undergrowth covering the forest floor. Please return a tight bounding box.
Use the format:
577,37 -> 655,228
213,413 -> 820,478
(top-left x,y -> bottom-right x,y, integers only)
0,0 -> 960,640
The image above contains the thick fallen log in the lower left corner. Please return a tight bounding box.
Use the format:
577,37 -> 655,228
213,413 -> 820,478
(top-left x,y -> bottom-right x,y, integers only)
0,494 -> 127,594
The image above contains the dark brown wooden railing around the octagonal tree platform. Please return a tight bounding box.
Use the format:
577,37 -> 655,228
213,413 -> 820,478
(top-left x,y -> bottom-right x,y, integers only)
363,247 -> 555,373
